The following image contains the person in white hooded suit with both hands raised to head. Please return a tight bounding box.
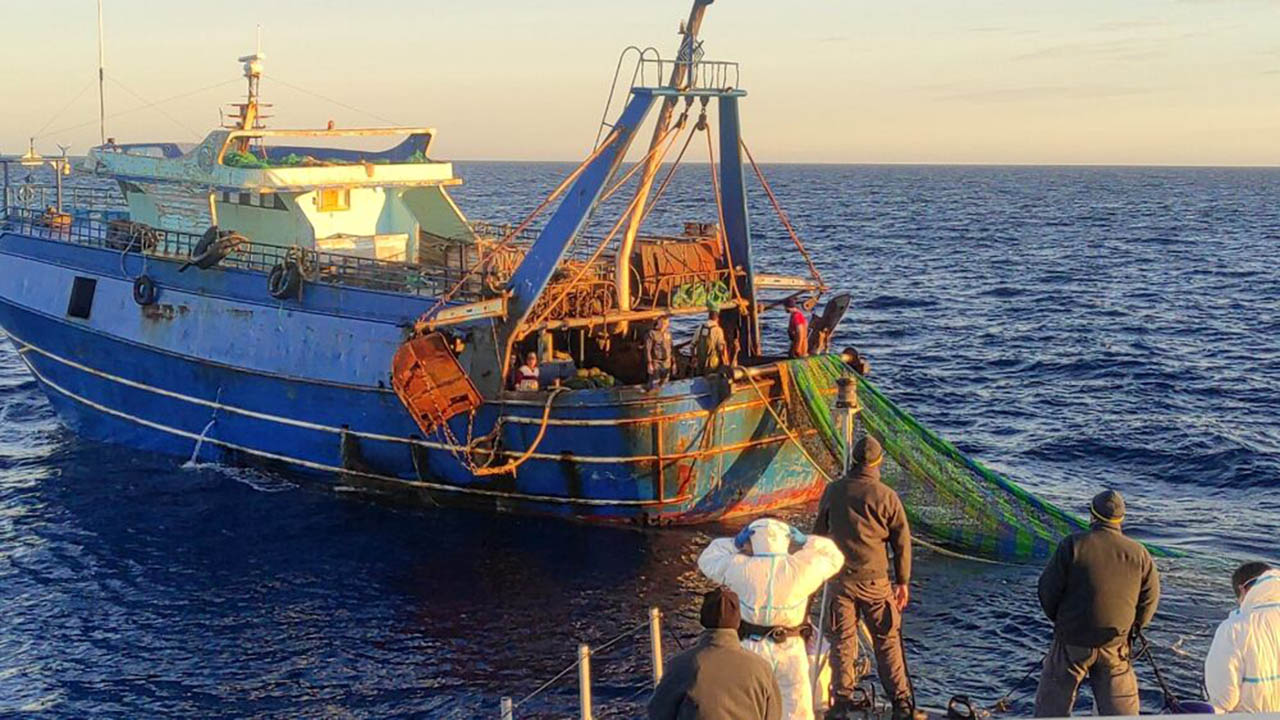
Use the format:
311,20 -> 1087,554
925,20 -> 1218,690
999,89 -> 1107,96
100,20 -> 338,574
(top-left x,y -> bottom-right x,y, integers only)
698,518 -> 845,720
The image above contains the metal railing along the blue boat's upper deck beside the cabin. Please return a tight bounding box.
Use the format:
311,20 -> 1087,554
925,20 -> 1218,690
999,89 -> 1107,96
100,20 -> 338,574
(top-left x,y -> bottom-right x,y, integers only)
0,206 -> 483,296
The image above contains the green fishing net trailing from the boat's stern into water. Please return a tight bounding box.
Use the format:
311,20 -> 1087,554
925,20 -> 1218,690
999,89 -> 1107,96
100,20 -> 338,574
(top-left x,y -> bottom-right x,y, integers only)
785,355 -> 1175,562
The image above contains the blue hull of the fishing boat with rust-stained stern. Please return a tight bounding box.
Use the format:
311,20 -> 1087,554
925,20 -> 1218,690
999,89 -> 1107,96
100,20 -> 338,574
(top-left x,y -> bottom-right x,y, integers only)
0,232 -> 823,523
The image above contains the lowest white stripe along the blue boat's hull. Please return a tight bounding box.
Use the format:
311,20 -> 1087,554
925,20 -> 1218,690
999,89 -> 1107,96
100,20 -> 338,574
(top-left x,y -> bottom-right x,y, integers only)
12,346 -> 692,507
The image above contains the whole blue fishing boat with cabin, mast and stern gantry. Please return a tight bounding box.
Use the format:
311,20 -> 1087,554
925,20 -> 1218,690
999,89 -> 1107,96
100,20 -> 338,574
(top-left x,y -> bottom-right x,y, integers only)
0,0 -> 861,524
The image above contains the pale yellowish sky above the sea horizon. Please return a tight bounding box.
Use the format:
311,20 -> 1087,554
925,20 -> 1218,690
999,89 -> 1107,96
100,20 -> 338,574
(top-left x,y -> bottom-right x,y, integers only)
0,0 -> 1280,165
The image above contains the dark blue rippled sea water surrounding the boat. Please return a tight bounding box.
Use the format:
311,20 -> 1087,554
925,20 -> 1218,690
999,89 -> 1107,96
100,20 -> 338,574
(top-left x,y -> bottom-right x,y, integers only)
0,163 -> 1280,717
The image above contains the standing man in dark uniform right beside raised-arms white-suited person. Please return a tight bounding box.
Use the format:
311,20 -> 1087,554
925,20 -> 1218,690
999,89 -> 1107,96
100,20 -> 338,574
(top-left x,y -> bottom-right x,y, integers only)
813,436 -> 914,719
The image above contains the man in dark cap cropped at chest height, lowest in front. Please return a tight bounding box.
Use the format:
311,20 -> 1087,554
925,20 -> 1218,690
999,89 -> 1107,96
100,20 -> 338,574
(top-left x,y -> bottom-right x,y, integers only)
649,588 -> 782,720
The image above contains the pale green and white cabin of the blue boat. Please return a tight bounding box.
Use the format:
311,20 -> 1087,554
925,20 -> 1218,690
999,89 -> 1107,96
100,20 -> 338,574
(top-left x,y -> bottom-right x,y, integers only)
90,127 -> 471,261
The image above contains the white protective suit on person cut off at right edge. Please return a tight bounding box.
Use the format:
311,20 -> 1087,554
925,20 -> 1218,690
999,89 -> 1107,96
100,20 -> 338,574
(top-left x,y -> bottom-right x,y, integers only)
1204,570 -> 1280,712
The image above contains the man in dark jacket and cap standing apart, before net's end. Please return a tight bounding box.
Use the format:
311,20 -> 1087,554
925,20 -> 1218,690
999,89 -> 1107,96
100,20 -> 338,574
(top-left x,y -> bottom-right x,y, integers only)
1036,489 -> 1160,717
